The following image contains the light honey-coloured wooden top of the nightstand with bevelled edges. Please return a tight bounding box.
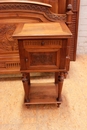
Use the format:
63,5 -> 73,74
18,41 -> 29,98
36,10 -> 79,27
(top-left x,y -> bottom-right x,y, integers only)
13,22 -> 72,39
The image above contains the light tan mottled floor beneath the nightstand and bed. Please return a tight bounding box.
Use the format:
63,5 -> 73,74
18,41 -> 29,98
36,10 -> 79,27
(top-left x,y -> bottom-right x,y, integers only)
0,55 -> 87,130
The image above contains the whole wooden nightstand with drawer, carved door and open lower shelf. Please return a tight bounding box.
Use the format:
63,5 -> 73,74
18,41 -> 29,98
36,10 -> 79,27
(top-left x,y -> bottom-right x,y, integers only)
13,21 -> 72,105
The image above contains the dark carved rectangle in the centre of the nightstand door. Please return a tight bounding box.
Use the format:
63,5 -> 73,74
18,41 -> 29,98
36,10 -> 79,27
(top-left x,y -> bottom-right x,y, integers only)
30,52 -> 56,66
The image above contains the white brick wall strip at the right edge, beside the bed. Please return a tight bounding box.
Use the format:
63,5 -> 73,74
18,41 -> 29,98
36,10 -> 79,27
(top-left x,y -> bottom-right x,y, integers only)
77,0 -> 87,54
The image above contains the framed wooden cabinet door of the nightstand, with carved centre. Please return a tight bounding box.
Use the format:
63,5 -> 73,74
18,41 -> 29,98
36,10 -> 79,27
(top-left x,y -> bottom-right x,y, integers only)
24,49 -> 60,71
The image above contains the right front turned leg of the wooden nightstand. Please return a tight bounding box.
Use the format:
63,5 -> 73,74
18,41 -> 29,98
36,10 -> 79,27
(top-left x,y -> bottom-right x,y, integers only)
57,73 -> 64,106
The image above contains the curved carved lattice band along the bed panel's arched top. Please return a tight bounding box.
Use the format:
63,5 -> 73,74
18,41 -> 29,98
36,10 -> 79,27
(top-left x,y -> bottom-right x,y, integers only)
0,3 -> 66,21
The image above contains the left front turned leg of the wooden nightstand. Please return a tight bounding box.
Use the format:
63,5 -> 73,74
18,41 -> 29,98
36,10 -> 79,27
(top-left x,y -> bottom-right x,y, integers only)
22,73 -> 30,102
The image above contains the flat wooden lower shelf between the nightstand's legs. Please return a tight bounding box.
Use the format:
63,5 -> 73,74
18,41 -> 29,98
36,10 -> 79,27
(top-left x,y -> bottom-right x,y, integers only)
25,84 -> 62,105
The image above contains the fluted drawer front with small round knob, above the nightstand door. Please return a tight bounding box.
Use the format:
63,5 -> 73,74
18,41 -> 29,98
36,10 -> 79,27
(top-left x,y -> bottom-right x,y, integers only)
23,39 -> 62,49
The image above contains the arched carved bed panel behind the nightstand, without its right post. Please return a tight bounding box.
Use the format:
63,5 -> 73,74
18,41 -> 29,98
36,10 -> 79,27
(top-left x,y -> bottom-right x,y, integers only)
0,0 -> 72,73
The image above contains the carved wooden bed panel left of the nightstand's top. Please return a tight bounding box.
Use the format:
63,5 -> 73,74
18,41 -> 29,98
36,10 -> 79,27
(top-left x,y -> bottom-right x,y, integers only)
0,24 -> 18,51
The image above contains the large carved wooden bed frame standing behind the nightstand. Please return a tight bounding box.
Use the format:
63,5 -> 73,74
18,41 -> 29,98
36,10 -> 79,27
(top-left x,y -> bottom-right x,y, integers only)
0,0 -> 79,74
